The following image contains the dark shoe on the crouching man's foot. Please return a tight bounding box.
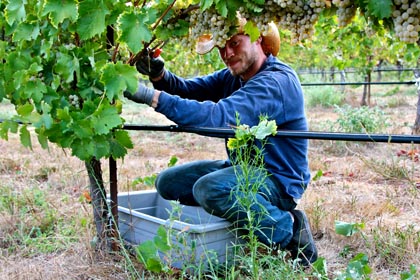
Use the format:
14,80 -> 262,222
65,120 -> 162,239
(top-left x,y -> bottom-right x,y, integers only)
286,210 -> 318,267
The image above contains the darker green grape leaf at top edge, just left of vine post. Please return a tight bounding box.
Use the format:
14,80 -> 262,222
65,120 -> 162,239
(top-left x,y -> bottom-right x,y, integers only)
77,0 -> 110,40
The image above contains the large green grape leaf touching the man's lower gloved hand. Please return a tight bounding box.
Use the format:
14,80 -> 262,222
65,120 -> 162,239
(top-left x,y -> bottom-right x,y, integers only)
100,61 -> 138,100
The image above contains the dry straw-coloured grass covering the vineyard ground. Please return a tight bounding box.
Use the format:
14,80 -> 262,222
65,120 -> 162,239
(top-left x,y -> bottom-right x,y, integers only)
0,85 -> 420,279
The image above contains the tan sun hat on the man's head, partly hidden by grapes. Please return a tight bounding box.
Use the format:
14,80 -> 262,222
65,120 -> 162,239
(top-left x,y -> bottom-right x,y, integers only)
195,18 -> 280,56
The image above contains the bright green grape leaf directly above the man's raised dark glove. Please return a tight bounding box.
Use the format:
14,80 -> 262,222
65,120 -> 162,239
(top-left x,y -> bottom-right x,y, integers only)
118,12 -> 153,53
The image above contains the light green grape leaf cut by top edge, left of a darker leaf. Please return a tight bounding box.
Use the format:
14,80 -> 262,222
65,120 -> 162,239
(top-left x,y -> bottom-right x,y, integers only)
42,0 -> 78,28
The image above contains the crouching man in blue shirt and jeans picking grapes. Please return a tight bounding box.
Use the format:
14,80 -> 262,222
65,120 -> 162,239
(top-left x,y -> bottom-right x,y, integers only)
125,20 -> 318,266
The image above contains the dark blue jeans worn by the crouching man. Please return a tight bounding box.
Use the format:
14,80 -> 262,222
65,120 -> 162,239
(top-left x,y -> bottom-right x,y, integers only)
156,160 -> 296,248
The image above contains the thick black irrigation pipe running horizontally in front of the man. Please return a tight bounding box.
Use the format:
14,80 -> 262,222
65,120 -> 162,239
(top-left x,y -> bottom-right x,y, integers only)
123,124 -> 420,144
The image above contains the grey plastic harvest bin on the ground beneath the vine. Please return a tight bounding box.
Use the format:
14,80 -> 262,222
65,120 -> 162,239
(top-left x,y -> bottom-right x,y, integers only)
118,190 -> 243,268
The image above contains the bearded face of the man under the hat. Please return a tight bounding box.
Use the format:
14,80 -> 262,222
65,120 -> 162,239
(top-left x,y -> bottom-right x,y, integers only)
219,34 -> 259,79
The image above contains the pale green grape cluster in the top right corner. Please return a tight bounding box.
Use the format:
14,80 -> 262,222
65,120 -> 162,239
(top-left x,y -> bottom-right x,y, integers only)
392,0 -> 420,43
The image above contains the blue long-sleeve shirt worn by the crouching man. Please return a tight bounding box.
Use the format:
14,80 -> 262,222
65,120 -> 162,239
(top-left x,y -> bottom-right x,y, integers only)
153,56 -> 310,199
